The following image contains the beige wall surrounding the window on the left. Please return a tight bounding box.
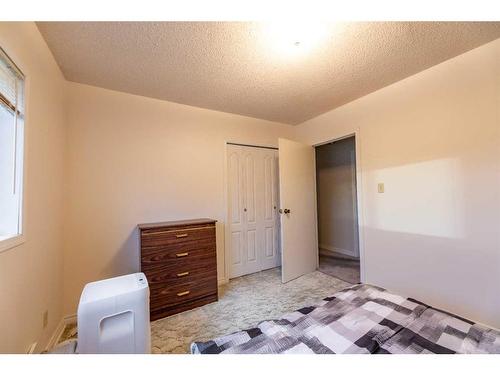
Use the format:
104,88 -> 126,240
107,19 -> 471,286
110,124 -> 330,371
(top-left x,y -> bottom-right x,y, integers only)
0,22 -> 65,353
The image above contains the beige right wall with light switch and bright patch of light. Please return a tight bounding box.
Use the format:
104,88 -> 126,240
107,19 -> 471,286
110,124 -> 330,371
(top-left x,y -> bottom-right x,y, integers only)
297,40 -> 500,327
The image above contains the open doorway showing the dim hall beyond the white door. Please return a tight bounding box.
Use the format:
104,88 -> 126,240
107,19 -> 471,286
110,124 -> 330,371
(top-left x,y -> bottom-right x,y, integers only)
316,135 -> 360,284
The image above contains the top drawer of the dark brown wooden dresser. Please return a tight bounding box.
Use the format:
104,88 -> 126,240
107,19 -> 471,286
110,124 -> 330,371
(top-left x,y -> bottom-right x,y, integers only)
141,225 -> 215,248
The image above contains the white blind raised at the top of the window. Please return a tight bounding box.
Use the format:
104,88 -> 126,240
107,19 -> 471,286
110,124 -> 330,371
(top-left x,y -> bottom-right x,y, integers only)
0,49 -> 24,115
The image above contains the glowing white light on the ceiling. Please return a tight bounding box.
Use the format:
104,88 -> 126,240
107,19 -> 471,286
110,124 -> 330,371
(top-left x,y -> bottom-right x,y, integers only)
262,19 -> 330,59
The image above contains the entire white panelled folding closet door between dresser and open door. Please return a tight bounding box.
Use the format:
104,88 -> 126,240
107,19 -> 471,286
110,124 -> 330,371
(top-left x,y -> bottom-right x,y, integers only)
226,145 -> 281,278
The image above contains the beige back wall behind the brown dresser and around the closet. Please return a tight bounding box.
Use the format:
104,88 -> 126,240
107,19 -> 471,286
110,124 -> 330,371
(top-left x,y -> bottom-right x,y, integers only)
64,83 -> 293,314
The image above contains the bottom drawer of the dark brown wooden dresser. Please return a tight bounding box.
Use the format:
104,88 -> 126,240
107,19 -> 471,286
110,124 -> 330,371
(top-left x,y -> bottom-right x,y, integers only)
150,274 -> 217,311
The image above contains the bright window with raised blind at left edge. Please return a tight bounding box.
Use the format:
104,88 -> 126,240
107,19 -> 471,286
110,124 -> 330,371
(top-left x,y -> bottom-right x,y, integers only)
0,48 -> 24,251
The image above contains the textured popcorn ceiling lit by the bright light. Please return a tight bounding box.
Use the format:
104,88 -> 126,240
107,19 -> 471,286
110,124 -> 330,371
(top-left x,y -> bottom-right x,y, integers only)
37,22 -> 500,124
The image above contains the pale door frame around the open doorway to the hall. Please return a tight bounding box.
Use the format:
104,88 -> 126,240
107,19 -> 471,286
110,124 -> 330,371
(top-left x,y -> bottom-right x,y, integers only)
313,128 -> 366,283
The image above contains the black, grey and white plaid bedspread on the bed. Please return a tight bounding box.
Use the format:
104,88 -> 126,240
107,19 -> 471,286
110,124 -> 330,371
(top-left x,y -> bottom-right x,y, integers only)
191,284 -> 500,354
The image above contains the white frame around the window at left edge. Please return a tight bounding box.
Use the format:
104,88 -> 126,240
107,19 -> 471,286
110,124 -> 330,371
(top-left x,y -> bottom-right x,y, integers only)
0,46 -> 29,253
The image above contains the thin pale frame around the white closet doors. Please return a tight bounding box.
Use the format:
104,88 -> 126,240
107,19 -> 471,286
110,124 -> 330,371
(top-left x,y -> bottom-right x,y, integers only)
224,140 -> 282,285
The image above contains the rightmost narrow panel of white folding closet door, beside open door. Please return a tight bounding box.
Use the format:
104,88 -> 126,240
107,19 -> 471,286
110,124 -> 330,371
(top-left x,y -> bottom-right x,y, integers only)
259,149 -> 281,270
